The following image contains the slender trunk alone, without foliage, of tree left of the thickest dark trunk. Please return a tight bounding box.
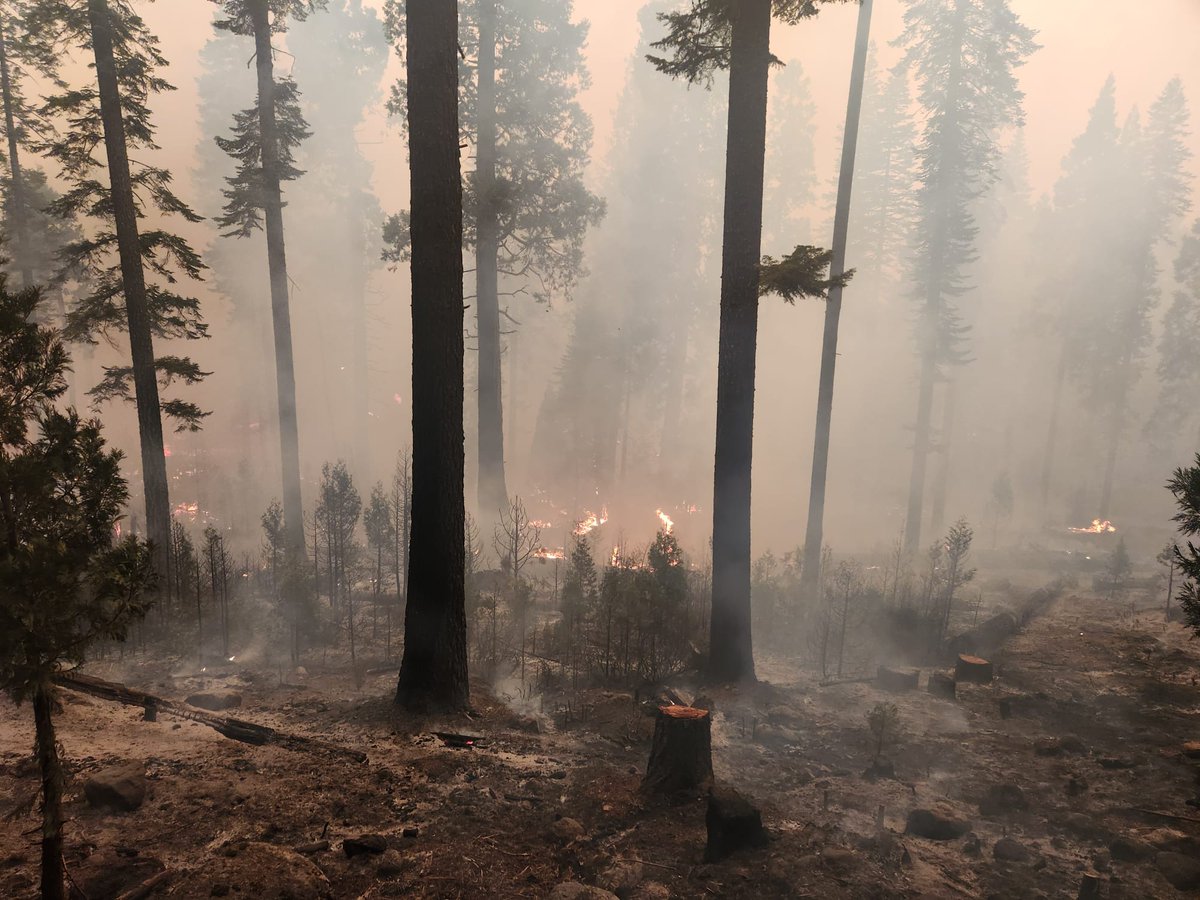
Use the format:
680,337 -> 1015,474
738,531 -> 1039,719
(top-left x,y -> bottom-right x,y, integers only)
250,0 -> 305,558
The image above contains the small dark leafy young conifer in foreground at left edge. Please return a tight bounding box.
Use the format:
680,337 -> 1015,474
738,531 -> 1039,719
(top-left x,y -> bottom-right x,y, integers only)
0,284 -> 152,900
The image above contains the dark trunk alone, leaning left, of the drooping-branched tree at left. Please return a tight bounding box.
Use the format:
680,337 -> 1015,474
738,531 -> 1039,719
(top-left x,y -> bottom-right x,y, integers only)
88,0 -> 170,587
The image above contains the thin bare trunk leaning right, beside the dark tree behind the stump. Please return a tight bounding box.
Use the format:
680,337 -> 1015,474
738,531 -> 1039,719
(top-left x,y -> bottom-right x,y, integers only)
800,0 -> 872,599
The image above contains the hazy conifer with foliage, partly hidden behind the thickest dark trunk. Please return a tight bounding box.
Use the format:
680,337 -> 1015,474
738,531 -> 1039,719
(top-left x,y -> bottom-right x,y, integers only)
385,0 -> 604,520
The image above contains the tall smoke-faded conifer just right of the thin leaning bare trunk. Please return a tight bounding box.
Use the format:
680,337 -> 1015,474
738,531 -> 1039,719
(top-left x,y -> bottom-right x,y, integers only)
896,0 -> 1037,554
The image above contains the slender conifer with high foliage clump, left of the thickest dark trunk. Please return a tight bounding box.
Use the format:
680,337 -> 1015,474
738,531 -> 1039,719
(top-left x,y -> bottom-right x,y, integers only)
212,0 -> 324,556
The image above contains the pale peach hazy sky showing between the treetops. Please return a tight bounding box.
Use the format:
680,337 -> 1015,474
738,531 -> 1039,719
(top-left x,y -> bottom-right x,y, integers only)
136,0 -> 1200,218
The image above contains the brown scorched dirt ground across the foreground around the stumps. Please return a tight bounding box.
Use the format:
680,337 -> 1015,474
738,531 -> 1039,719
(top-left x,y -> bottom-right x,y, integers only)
0,594 -> 1200,900
